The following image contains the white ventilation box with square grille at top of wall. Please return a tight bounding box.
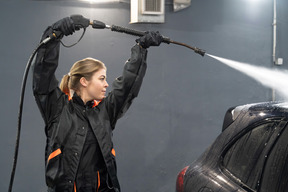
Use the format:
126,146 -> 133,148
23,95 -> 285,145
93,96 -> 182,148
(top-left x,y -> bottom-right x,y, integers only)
130,0 -> 165,23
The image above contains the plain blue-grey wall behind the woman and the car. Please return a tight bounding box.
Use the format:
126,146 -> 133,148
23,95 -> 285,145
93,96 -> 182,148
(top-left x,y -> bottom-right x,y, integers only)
0,0 -> 288,192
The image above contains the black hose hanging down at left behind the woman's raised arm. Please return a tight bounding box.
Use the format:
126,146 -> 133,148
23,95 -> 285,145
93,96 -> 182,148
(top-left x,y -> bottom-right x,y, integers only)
8,38 -> 51,192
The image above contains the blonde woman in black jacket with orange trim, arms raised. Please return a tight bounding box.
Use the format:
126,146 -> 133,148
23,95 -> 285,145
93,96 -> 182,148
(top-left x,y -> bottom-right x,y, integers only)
33,18 -> 162,192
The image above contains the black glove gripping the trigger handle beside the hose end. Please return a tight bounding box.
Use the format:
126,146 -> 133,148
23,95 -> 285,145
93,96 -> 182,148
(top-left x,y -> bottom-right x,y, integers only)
52,17 -> 75,36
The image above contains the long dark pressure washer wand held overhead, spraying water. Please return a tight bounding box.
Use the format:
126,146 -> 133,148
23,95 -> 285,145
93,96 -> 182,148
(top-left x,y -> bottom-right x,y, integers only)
90,20 -> 205,57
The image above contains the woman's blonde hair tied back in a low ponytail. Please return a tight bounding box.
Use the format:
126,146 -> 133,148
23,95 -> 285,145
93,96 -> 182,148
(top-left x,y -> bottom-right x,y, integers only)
59,57 -> 106,97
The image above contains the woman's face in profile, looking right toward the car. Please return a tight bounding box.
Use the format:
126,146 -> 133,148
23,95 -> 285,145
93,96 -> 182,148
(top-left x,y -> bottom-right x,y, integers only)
86,69 -> 109,100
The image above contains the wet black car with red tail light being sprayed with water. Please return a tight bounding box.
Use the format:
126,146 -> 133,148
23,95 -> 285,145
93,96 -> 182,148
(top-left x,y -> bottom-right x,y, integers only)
176,102 -> 288,192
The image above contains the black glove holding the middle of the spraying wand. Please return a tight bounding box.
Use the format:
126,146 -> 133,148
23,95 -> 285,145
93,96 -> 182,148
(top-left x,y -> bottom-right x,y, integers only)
136,31 -> 163,49
